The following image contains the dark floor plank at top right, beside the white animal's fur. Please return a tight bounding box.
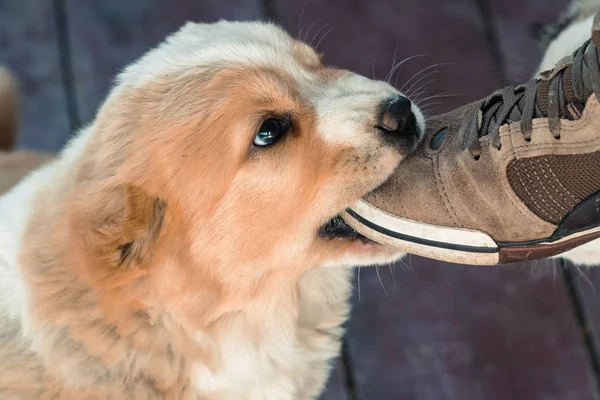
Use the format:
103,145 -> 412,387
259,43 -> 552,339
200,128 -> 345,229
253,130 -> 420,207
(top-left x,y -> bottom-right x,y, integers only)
486,0 -> 572,83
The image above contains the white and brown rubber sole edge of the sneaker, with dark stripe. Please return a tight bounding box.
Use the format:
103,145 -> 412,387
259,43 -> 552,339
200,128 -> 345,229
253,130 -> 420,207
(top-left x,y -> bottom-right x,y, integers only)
342,200 -> 600,265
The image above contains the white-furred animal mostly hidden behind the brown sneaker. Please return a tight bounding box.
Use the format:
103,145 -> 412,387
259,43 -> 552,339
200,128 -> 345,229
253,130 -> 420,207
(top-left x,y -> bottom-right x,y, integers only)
536,0 -> 600,266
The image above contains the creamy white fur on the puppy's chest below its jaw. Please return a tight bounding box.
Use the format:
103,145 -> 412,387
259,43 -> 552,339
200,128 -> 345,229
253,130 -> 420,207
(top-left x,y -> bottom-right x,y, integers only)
192,267 -> 351,400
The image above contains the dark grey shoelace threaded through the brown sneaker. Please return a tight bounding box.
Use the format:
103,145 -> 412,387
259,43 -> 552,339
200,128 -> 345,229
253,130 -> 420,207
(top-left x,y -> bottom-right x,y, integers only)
465,36 -> 600,160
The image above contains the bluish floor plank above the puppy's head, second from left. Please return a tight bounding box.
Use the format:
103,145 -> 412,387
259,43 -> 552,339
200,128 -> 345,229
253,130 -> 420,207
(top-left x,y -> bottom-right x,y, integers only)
67,0 -> 261,126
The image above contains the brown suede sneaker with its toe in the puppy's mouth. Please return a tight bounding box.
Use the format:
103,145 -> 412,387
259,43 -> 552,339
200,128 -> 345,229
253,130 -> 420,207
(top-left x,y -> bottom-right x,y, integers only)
343,15 -> 600,265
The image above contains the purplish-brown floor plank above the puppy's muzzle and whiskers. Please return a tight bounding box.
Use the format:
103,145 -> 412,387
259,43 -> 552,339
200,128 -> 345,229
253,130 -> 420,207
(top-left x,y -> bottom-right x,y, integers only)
272,0 -> 499,113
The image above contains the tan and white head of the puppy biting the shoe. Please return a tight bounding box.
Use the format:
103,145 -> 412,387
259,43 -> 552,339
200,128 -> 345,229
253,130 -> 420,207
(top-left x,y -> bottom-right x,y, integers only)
64,22 -> 423,310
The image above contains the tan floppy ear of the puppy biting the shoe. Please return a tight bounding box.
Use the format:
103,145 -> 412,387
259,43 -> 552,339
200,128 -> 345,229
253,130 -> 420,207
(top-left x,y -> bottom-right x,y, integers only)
71,185 -> 167,288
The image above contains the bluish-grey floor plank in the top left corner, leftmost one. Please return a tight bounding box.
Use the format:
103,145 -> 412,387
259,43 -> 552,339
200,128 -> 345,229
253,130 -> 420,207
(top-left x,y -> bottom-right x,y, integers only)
0,0 -> 69,150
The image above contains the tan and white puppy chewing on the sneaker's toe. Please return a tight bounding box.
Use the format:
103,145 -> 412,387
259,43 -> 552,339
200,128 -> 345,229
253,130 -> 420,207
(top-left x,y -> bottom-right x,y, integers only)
0,22 -> 423,400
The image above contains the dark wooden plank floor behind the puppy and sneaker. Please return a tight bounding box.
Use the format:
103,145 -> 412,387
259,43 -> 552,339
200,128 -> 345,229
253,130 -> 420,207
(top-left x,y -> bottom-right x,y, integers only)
0,0 -> 600,400
